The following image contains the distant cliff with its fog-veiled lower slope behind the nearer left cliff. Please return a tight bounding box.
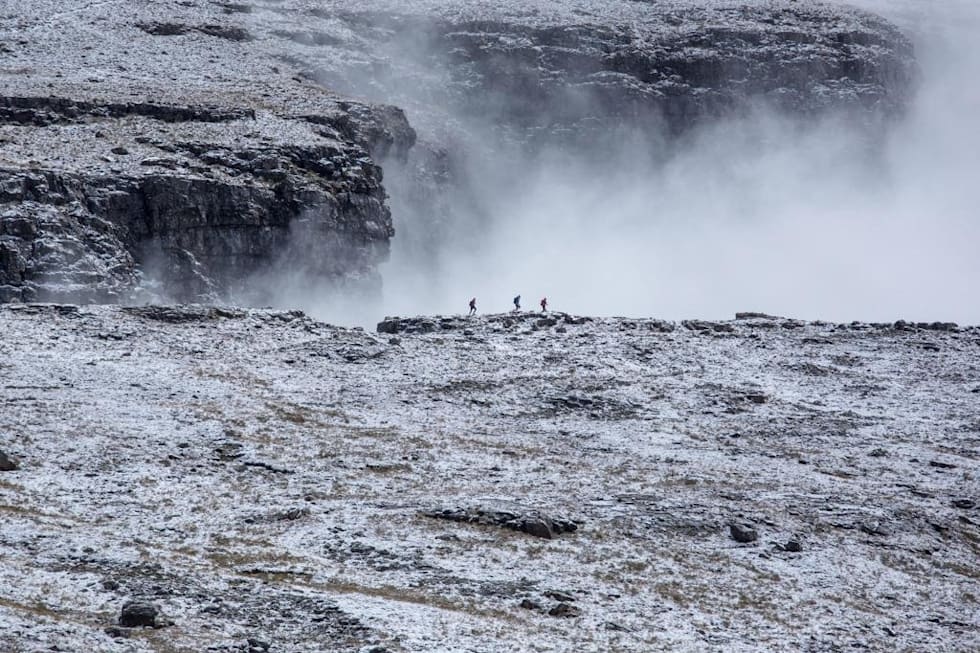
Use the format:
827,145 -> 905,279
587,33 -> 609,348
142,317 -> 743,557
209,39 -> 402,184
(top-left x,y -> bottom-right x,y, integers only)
249,0 -> 916,270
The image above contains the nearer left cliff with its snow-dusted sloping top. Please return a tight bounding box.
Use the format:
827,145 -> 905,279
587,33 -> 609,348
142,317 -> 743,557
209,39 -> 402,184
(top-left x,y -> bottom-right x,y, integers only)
0,2 -> 414,303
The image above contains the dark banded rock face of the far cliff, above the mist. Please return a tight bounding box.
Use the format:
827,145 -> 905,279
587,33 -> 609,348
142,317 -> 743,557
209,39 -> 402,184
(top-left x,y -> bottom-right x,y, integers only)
302,0 -> 913,142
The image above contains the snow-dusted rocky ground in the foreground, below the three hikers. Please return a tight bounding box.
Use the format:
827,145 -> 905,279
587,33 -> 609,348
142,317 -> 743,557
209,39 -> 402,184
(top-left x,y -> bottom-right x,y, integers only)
0,305 -> 980,652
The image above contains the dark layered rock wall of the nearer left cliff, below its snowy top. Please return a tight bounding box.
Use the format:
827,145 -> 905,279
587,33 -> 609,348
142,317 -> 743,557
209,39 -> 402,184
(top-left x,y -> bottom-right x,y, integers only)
0,98 -> 407,302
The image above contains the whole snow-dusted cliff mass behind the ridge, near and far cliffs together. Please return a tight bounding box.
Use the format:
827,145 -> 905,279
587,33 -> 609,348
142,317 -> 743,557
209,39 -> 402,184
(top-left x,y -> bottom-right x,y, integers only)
0,0 -> 913,303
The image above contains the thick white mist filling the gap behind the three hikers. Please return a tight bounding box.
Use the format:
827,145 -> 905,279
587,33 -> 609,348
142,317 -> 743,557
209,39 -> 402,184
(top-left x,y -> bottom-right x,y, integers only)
286,0 -> 980,323
